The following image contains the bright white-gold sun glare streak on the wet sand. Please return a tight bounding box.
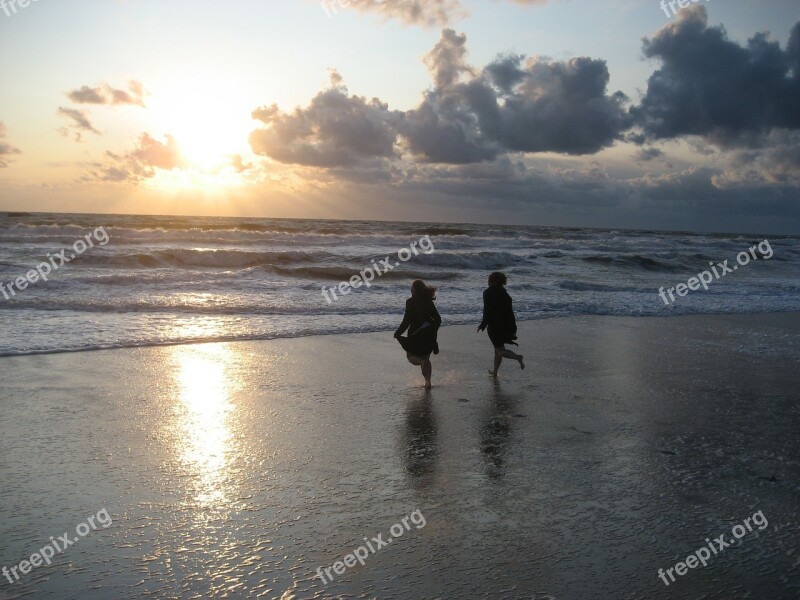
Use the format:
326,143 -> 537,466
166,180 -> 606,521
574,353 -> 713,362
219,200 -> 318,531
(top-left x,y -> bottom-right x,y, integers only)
173,344 -> 236,508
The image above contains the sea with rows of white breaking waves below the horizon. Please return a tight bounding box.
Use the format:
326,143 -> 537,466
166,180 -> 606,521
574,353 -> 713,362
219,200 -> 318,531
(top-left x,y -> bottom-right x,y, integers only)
0,212 -> 800,356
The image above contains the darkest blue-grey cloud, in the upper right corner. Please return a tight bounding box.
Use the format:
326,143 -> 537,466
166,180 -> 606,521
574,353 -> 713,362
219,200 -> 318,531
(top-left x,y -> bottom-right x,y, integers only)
631,5 -> 800,147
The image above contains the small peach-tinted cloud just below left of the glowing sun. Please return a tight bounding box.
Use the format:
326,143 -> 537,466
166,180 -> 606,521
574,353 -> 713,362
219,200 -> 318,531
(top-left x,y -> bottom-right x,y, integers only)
82,133 -> 185,182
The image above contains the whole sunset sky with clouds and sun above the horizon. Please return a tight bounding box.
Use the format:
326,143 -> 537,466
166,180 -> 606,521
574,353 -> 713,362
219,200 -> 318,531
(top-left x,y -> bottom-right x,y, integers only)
0,0 -> 800,234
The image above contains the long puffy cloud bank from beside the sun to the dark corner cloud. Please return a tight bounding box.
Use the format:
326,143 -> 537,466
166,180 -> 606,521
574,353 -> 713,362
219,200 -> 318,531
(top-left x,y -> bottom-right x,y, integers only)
250,29 -> 630,168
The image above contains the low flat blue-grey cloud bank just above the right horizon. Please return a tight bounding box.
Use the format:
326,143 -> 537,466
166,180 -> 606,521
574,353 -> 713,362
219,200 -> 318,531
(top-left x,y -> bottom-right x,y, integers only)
390,157 -> 800,232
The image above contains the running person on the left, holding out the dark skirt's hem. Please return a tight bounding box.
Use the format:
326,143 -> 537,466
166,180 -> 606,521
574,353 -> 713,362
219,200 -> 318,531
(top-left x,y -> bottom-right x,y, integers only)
394,279 -> 442,390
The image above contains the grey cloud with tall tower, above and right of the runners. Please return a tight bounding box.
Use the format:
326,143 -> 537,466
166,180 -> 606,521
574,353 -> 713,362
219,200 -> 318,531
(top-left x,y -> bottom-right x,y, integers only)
402,29 -> 629,164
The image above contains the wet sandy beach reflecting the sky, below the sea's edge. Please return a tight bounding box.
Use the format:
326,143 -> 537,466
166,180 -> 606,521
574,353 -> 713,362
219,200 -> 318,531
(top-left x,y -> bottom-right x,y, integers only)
0,313 -> 800,600
